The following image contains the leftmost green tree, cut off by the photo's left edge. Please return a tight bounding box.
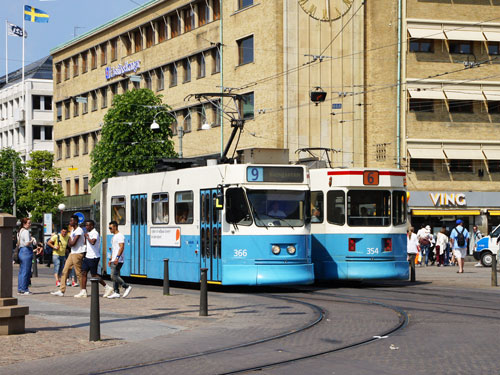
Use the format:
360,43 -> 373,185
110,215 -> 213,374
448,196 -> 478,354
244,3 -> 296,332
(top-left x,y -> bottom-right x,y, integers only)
0,148 -> 26,217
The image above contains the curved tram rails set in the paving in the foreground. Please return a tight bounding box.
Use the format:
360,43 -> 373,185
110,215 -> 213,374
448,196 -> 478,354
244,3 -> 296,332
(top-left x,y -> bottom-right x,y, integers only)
93,292 -> 408,375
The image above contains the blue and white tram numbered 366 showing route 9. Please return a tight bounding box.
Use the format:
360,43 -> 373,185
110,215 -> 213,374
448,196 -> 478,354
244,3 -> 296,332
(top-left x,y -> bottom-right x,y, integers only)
101,164 -> 314,285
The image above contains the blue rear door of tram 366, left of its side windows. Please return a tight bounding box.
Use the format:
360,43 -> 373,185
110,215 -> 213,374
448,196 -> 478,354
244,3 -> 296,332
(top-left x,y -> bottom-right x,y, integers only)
130,194 -> 148,275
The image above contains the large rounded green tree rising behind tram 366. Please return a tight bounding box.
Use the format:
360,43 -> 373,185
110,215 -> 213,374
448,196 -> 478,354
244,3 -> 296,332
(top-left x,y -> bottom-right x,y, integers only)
90,89 -> 177,186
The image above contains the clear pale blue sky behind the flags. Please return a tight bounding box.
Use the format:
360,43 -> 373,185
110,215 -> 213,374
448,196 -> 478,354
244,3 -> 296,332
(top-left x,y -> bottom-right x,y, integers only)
0,0 -> 148,77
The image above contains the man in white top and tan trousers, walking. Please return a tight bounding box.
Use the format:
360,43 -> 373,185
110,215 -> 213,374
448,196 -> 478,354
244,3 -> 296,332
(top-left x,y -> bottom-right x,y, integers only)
50,215 -> 85,297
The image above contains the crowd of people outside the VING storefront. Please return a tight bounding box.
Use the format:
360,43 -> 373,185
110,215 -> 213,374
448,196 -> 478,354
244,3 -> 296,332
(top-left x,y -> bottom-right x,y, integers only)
407,219 -> 482,273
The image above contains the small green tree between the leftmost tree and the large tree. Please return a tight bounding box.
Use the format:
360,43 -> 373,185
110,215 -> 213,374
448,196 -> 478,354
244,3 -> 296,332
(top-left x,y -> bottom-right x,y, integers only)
18,151 -> 63,223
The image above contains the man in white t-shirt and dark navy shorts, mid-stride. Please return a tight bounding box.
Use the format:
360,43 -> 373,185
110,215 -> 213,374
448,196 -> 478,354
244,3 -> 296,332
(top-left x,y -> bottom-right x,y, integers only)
74,220 -> 113,298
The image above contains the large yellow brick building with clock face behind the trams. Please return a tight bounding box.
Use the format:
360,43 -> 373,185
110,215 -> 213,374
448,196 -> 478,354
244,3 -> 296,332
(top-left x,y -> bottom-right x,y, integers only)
51,0 -> 500,232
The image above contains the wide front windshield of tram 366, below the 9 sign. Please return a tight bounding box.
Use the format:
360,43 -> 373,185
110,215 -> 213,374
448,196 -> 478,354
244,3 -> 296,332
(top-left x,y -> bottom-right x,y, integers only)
247,189 -> 308,227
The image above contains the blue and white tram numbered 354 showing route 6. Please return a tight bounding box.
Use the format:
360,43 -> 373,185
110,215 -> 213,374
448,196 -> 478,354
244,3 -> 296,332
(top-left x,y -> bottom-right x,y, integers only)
310,168 -> 408,280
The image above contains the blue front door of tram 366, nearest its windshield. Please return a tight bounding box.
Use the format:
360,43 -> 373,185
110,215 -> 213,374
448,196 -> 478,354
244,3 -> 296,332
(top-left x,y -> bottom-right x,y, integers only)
200,189 -> 222,281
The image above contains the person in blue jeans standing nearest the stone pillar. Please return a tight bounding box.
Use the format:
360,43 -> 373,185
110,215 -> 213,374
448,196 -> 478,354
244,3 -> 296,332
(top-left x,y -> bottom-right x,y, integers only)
17,217 -> 43,295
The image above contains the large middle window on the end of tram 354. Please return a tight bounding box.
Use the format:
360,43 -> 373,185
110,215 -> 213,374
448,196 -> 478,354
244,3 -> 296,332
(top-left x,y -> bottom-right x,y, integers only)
347,190 -> 391,227
